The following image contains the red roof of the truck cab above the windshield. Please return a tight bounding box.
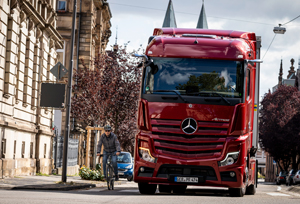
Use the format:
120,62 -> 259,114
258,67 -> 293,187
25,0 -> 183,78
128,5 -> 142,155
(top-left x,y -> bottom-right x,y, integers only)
146,28 -> 256,61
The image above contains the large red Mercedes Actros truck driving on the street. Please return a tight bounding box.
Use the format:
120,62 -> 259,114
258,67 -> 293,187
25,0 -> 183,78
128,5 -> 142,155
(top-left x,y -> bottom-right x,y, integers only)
134,28 -> 262,197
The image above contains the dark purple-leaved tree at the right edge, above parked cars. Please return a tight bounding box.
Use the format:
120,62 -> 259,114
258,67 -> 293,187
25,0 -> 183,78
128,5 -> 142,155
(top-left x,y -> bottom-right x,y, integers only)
259,85 -> 300,171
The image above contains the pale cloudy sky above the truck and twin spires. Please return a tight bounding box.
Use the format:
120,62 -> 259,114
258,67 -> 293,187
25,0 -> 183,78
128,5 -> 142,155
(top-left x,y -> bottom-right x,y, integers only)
107,0 -> 300,100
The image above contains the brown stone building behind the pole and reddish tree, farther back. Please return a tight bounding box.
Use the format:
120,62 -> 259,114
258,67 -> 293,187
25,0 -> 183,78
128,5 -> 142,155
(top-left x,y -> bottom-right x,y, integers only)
54,0 -> 112,173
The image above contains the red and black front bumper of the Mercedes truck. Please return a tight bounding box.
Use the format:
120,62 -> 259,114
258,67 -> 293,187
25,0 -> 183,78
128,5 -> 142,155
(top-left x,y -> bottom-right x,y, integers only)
134,160 -> 244,188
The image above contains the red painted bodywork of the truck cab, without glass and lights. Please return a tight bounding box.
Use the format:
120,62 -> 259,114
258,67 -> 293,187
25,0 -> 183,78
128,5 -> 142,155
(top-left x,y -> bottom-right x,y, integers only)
134,28 -> 256,188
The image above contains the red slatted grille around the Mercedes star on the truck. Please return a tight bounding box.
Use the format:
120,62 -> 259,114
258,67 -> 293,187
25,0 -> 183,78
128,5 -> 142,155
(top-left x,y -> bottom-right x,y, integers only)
151,119 -> 229,158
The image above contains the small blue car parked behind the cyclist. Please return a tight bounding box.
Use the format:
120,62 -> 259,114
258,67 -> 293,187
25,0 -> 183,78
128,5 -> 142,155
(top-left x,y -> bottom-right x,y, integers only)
117,152 -> 133,181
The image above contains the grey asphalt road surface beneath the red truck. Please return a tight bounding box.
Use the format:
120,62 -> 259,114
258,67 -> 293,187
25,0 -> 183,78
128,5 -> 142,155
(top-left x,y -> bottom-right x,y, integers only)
0,182 -> 300,204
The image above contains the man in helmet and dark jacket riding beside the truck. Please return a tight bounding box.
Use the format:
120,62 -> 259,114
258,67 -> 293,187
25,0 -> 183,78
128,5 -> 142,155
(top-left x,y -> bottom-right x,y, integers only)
97,125 -> 121,181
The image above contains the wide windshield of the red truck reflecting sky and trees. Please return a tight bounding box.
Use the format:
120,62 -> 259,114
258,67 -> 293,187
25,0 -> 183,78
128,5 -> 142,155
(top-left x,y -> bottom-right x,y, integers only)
143,58 -> 244,98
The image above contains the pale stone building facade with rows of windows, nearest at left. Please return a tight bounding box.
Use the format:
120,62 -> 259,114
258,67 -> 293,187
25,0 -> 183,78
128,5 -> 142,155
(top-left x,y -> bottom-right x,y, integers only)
0,0 -> 62,178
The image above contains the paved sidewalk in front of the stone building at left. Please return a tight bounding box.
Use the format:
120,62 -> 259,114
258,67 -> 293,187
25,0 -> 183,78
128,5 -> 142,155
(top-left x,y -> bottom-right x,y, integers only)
0,175 -> 127,191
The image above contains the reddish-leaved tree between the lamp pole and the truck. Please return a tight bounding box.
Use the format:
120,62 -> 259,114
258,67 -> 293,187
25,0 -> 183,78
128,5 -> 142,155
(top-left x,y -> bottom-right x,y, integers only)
71,48 -> 141,152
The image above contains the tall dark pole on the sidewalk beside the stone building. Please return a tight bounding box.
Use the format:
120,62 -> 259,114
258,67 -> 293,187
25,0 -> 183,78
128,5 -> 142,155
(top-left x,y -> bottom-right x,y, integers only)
62,0 -> 77,182
